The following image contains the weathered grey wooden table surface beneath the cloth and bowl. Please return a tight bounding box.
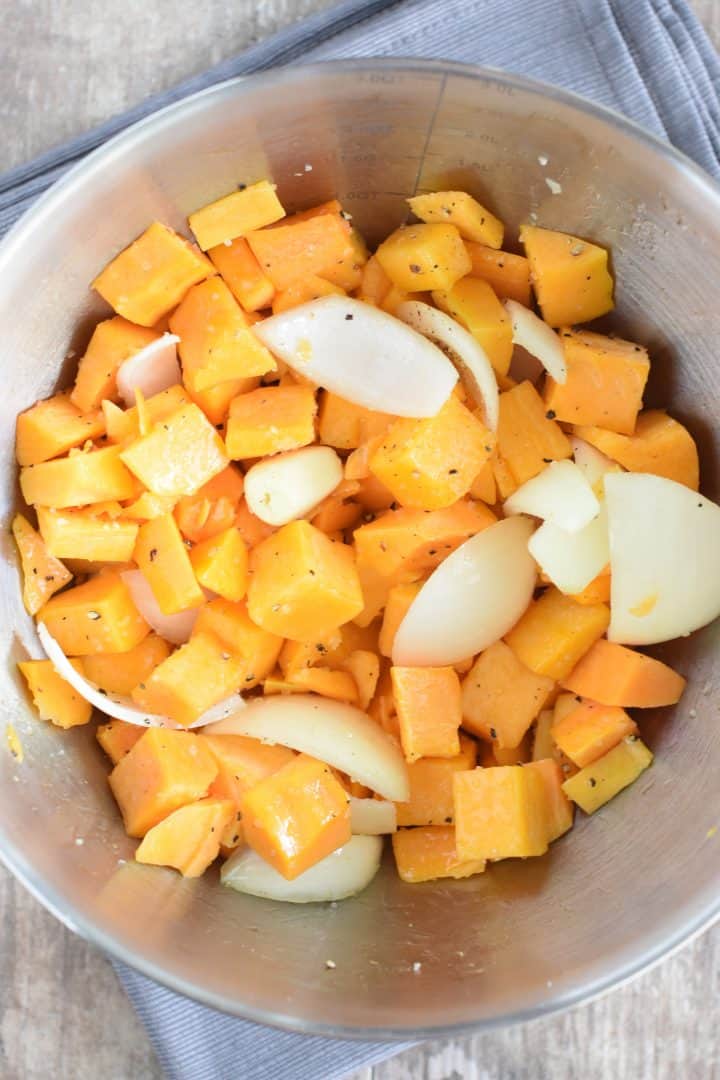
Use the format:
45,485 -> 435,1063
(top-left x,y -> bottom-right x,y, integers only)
0,0 -> 720,1080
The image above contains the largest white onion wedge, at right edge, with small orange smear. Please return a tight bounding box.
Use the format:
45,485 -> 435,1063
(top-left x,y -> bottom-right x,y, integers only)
604,473 -> 720,645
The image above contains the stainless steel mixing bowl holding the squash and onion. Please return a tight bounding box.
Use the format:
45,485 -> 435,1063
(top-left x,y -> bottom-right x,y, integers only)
0,60 -> 720,1038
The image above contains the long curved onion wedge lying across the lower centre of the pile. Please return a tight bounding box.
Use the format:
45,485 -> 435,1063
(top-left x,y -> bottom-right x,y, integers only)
202,693 -> 409,802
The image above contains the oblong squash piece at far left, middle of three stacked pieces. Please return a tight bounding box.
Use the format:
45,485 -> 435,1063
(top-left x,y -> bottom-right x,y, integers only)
21,446 -> 139,510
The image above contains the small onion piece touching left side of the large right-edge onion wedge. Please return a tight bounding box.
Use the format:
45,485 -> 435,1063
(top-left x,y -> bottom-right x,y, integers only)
528,505 -> 610,594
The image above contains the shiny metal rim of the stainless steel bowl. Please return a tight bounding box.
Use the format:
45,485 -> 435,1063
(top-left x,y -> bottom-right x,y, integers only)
0,56 -> 720,1044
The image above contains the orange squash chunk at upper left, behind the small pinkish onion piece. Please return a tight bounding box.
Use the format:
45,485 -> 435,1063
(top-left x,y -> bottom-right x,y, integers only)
70,315 -> 160,413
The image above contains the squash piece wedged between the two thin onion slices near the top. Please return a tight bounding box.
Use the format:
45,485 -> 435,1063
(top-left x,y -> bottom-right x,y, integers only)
433,276 -> 513,375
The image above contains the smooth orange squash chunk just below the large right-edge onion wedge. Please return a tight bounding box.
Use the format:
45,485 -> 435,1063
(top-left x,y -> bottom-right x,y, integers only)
562,638 -> 685,708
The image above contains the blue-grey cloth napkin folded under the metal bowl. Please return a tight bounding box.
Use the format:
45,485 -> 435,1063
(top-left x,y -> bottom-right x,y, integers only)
0,0 -> 720,1080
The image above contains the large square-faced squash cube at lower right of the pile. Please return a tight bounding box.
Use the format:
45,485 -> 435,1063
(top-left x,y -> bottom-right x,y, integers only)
452,765 -> 548,860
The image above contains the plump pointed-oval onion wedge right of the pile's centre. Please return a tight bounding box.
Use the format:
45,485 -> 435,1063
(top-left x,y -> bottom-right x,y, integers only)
390,517 -> 536,665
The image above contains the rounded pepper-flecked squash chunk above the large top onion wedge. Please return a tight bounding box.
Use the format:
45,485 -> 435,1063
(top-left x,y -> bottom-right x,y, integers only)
376,225 -> 471,291
